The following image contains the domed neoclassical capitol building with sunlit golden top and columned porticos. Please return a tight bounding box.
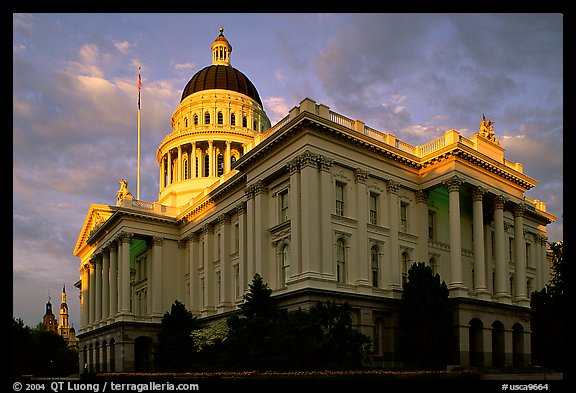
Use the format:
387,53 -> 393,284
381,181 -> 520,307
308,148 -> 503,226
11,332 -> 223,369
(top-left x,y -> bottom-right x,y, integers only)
73,29 -> 555,372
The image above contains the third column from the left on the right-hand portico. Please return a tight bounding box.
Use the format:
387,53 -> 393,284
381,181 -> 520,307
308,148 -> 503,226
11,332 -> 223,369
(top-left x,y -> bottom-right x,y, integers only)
494,195 -> 510,303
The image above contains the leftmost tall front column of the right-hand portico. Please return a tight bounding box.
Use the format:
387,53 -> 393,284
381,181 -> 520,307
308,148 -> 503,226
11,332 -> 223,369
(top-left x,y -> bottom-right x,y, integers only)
444,176 -> 464,296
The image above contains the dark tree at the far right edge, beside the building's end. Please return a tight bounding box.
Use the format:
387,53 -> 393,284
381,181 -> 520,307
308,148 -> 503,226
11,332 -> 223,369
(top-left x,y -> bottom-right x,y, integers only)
530,241 -> 568,371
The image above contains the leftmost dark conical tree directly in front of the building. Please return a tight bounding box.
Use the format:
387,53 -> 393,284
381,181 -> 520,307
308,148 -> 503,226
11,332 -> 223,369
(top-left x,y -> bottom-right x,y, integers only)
155,300 -> 198,371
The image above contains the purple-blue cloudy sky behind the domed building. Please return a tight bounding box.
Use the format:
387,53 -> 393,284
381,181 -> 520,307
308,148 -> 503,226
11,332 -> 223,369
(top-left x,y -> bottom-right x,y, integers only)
12,13 -> 564,331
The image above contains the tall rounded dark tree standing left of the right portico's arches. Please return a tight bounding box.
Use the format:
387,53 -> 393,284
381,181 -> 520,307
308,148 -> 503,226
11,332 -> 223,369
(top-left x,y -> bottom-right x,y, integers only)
399,262 -> 454,370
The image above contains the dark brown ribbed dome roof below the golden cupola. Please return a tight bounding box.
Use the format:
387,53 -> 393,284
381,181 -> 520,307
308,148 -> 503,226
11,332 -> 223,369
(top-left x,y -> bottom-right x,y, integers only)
180,64 -> 262,106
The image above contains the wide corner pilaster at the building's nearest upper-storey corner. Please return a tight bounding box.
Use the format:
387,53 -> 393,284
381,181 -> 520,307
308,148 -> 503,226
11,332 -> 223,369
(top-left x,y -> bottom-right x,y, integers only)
299,150 -> 320,275
